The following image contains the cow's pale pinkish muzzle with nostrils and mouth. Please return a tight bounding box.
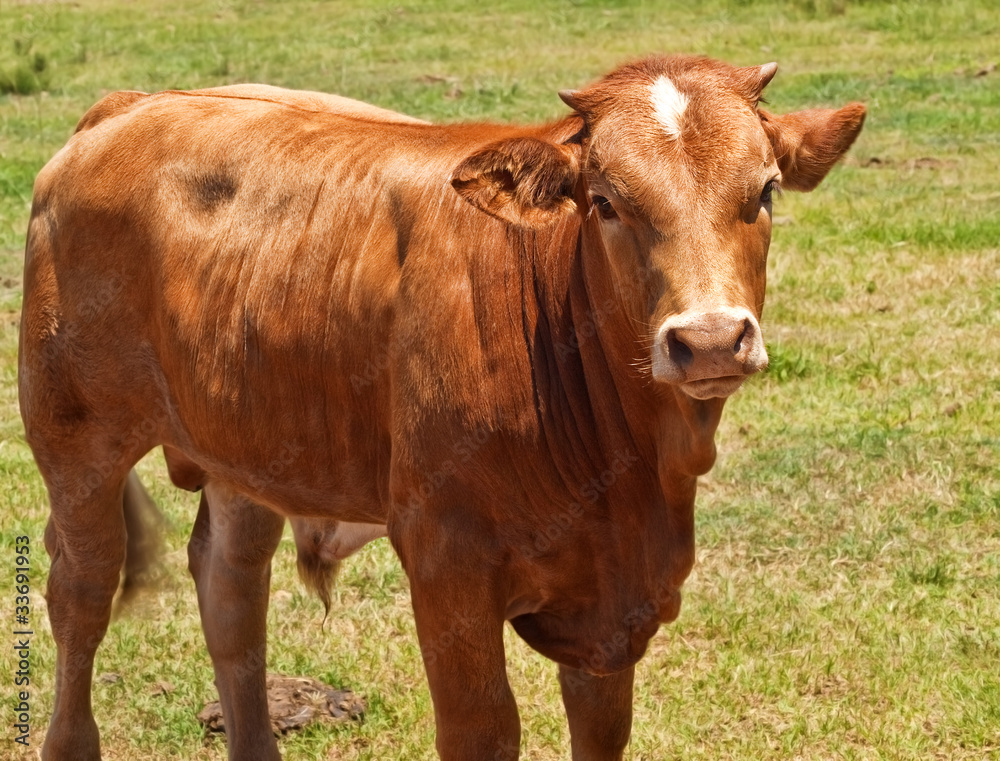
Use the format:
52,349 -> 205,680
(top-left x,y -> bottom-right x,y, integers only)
653,307 -> 767,399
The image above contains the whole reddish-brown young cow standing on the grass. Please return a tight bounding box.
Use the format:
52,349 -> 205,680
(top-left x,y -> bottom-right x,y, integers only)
20,57 -> 865,761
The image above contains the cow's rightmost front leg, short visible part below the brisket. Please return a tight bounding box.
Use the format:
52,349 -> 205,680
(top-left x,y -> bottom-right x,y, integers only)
559,665 -> 635,761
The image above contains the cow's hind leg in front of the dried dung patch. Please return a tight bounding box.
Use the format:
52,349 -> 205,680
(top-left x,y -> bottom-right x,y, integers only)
188,483 -> 284,761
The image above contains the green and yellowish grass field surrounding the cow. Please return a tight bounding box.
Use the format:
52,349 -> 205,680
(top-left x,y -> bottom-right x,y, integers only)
0,0 -> 1000,761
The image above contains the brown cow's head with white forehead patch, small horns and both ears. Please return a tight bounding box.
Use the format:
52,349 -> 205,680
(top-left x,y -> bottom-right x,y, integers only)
452,57 -> 865,399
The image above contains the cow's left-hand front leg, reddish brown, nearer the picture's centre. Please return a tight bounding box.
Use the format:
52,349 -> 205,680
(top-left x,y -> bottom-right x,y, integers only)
408,553 -> 521,761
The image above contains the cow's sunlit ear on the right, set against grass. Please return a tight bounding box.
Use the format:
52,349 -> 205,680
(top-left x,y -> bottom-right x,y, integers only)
758,103 -> 865,190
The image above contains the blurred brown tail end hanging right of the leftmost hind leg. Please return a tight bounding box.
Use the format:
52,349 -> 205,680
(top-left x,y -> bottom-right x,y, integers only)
118,470 -> 163,610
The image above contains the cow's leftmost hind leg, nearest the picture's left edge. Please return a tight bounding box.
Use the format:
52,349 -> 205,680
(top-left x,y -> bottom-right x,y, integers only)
39,472 -> 127,761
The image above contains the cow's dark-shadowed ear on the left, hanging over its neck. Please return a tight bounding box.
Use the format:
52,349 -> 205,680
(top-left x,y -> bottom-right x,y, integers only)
451,137 -> 580,228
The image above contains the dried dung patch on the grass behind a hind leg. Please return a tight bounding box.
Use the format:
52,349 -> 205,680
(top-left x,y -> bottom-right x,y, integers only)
198,674 -> 365,735
